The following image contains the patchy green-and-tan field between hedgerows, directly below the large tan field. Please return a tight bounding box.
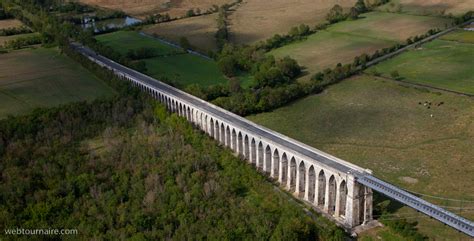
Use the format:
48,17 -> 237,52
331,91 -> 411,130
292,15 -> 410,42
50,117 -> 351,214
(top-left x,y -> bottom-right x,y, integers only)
270,12 -> 451,79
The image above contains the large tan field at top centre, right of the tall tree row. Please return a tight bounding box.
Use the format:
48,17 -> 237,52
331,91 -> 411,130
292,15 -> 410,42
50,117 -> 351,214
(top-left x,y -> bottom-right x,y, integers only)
229,0 -> 356,44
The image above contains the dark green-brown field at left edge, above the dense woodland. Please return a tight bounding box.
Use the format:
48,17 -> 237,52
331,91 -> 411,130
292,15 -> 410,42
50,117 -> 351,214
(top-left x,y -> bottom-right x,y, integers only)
0,48 -> 114,118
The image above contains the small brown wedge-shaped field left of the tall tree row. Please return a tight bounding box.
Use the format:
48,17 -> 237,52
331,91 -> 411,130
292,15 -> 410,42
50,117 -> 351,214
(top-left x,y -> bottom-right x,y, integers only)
144,14 -> 217,51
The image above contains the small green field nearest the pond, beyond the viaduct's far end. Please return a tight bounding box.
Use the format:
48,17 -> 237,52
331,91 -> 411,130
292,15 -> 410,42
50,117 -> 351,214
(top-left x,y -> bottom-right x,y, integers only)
96,31 -> 177,54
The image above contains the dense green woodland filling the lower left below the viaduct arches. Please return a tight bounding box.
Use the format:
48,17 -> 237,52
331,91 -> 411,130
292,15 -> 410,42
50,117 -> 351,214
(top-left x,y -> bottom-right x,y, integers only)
0,43 -> 344,240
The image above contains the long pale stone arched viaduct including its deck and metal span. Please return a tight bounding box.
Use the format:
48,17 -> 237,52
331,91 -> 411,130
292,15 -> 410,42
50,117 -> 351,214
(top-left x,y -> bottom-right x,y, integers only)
72,44 -> 474,236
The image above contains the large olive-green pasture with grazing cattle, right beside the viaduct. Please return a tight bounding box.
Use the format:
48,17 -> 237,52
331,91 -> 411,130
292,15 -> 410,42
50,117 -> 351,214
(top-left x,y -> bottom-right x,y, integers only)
248,76 -> 474,240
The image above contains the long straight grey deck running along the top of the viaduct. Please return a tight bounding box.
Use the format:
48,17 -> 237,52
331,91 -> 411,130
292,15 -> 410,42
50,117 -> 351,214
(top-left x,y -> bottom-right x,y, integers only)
72,44 -> 474,237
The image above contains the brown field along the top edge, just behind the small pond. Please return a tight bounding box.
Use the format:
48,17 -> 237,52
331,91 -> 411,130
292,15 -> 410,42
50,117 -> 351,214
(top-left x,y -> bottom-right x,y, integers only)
79,0 -> 233,17
